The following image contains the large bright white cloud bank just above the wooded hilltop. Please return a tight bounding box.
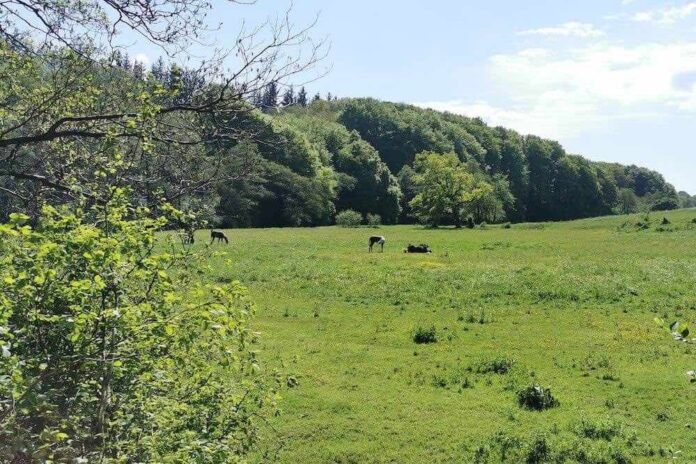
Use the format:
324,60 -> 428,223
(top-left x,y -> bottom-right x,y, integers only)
421,43 -> 696,139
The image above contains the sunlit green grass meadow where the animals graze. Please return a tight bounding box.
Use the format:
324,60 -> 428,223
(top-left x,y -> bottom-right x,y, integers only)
192,210 -> 696,463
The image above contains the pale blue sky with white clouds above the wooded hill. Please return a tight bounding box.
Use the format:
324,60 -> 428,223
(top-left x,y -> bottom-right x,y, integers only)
132,0 -> 696,194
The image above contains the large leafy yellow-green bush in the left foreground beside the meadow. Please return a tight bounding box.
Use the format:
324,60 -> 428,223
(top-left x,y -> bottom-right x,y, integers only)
0,190 -> 278,463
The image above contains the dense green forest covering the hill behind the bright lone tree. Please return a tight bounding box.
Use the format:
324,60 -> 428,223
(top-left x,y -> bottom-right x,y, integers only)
0,50 -> 696,227
